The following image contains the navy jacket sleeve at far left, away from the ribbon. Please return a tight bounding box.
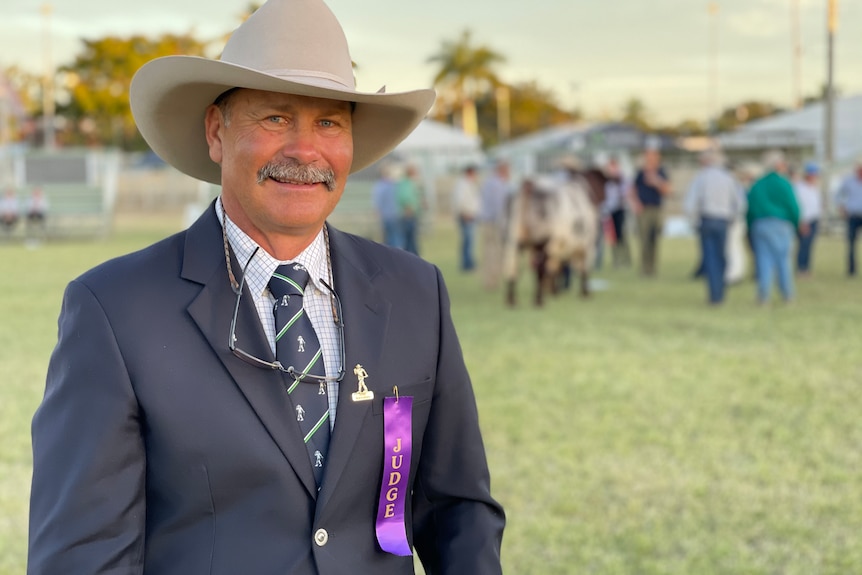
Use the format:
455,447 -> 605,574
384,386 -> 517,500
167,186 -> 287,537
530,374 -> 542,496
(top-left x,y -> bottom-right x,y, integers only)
27,282 -> 145,575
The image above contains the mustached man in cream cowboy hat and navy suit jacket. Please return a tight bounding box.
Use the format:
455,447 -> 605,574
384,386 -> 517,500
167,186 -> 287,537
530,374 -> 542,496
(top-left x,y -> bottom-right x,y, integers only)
28,0 -> 504,575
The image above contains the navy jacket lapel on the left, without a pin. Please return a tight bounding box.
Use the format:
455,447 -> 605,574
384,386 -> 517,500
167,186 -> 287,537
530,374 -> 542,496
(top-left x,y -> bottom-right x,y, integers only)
182,206 -> 318,497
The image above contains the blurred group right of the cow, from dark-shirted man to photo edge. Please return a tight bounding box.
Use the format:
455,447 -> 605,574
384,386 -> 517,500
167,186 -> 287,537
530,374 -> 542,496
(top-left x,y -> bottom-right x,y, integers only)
629,150 -> 862,305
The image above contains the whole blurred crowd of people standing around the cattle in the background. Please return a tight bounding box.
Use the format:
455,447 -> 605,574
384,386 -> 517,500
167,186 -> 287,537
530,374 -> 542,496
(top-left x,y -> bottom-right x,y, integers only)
374,148 -> 862,306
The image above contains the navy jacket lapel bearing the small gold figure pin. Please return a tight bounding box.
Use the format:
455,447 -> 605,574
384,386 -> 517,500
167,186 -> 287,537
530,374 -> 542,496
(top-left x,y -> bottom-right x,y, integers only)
318,227 -> 390,506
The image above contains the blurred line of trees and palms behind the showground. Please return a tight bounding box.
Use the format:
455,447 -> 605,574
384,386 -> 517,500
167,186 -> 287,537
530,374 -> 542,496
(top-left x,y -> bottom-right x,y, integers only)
3,16 -> 824,151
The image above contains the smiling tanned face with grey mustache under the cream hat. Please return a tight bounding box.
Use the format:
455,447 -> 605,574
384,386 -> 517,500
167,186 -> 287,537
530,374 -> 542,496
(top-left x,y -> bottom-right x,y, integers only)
206,89 -> 353,250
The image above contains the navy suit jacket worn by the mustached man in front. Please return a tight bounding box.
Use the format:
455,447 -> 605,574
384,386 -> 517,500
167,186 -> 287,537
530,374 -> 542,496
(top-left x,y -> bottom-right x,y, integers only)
28,206 -> 504,575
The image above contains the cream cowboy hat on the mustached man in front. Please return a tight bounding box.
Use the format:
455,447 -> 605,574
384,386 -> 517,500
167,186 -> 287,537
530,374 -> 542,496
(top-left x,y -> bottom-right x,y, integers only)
129,0 -> 434,184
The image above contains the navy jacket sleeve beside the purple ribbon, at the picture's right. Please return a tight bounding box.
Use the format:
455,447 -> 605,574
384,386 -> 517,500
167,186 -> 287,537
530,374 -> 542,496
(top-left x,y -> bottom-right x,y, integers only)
413,270 -> 505,575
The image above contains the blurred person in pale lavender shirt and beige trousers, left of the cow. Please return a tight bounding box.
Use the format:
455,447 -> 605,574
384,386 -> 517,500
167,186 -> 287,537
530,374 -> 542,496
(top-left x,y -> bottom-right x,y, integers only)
479,160 -> 512,291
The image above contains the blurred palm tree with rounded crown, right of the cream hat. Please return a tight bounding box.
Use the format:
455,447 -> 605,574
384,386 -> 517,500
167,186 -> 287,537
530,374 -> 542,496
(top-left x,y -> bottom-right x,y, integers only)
428,30 -> 506,134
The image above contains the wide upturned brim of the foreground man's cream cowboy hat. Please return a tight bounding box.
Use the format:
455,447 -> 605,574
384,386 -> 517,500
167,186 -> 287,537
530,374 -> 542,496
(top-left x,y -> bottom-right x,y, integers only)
129,56 -> 435,184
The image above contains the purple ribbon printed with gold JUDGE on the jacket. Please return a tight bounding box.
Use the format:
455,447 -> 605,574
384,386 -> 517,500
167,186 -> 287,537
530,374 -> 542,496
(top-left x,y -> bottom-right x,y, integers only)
376,396 -> 413,556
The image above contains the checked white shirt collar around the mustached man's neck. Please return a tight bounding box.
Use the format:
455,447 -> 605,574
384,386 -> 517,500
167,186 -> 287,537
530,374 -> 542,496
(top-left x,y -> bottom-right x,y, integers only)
215,197 -> 334,295
